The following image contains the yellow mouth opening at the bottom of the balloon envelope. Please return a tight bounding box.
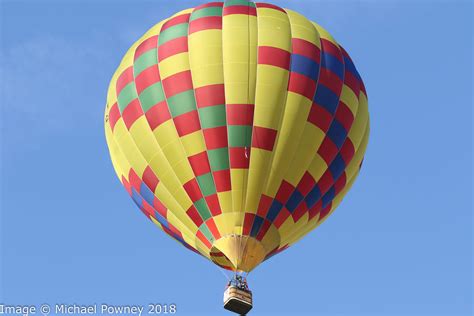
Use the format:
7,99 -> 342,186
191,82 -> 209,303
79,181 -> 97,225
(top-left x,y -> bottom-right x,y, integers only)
210,234 -> 268,273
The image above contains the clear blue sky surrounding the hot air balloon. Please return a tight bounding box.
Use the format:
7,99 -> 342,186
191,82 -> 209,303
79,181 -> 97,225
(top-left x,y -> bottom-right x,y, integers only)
0,0 -> 473,316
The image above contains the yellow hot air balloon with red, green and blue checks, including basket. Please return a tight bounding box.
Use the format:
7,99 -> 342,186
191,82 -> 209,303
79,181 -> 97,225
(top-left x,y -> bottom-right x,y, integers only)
105,0 -> 369,314
